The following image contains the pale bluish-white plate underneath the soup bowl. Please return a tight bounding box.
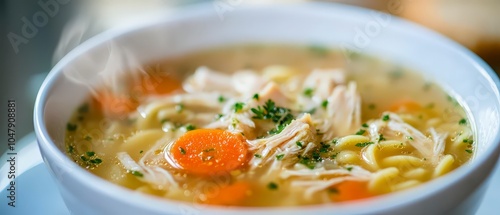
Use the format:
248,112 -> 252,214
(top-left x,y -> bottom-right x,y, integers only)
0,134 -> 500,215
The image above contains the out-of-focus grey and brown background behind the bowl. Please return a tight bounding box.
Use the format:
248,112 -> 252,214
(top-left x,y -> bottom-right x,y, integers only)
0,0 -> 500,154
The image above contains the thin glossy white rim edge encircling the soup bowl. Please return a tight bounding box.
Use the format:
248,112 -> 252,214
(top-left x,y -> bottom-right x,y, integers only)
34,2 -> 500,213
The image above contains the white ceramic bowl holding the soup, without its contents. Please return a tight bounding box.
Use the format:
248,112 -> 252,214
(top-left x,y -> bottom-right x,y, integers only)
34,3 -> 500,214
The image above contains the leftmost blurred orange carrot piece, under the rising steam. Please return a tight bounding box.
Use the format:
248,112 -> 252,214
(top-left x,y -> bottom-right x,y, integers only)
94,91 -> 139,117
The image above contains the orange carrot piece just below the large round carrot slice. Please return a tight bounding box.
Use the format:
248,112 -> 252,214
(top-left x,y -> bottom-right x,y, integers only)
205,181 -> 251,205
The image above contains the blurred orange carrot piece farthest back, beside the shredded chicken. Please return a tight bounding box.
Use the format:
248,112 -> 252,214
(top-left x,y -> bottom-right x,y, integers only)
138,74 -> 182,95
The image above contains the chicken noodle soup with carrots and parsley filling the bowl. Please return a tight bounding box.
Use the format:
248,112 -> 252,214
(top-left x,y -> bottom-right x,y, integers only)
66,45 -> 474,206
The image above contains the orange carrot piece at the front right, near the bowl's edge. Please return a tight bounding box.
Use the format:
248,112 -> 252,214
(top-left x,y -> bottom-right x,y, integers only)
330,181 -> 373,202
